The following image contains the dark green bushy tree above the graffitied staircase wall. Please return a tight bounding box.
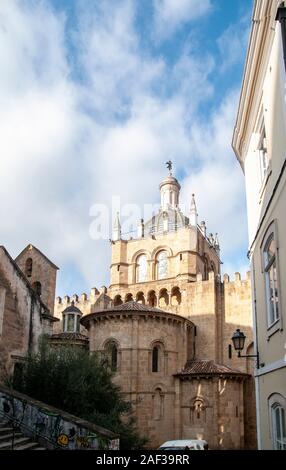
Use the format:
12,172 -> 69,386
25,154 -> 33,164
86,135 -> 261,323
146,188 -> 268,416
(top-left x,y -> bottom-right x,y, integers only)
10,342 -> 147,449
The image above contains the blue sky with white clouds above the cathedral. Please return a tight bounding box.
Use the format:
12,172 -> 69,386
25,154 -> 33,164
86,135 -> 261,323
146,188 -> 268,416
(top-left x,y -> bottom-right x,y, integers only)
0,0 -> 252,296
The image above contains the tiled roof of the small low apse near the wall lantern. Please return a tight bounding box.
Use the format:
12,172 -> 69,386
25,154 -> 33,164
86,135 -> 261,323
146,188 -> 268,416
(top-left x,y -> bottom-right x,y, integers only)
176,360 -> 245,376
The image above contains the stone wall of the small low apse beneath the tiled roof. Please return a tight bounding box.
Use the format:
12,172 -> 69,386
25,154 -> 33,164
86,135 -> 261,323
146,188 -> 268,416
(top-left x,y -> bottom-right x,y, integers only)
180,377 -> 244,449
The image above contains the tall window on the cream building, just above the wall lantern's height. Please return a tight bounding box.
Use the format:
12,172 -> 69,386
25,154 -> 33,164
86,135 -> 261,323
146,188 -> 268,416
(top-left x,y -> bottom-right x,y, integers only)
263,233 -> 280,327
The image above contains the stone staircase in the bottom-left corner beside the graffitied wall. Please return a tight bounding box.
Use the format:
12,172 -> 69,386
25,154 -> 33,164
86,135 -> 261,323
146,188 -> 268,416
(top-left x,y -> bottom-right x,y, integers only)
0,421 -> 46,450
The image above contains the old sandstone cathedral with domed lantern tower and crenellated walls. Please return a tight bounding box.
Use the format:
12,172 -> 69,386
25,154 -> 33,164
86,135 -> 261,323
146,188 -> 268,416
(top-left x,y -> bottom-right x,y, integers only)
0,171 -> 256,449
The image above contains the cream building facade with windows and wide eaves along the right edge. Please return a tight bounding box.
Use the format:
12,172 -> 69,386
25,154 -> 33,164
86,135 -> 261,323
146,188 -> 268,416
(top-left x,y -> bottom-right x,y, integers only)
232,0 -> 286,449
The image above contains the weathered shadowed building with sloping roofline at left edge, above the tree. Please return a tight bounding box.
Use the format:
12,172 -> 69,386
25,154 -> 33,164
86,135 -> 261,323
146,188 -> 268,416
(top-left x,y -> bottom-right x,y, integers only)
0,246 -> 57,382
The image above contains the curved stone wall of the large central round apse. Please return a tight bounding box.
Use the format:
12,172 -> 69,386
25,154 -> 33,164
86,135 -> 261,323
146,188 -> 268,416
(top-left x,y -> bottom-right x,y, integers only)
84,312 -> 194,448
